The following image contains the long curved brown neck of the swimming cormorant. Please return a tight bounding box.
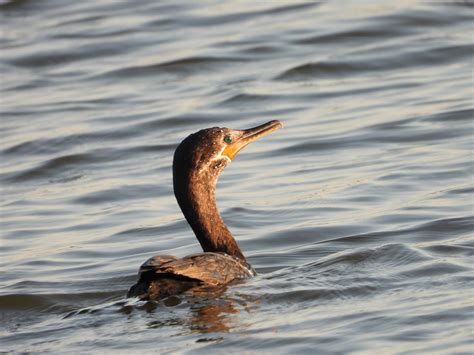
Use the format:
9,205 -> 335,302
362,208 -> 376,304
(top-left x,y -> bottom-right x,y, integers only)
173,167 -> 245,260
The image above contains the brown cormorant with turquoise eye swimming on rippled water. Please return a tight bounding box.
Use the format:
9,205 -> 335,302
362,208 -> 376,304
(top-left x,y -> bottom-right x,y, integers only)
127,120 -> 283,300
